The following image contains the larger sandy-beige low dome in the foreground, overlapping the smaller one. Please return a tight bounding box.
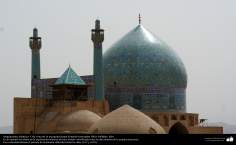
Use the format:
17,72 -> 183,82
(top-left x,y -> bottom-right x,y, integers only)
88,105 -> 165,134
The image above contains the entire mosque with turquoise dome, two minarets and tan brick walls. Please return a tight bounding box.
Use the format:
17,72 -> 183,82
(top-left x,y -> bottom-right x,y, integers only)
14,17 -> 223,134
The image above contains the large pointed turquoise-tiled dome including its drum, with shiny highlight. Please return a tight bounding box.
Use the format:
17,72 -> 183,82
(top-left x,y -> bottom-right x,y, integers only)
104,25 -> 187,111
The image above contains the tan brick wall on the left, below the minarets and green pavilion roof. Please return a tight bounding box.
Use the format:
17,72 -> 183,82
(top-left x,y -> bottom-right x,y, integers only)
14,98 -> 109,134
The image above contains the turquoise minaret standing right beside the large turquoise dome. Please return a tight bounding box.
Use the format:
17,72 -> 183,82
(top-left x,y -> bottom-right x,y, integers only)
91,20 -> 104,101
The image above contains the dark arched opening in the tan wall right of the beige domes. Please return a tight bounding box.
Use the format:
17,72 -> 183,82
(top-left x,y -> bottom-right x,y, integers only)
169,122 -> 189,134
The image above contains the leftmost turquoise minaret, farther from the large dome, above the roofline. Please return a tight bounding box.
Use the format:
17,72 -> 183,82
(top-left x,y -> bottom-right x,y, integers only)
29,28 -> 41,80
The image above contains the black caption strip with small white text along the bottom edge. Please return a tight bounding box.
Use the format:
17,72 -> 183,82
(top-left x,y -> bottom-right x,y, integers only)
1,134 -> 236,145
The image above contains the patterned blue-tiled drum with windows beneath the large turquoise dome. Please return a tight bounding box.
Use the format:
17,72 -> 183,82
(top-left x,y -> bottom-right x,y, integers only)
106,88 -> 186,112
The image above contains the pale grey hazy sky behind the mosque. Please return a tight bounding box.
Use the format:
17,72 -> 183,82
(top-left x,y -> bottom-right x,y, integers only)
0,0 -> 236,126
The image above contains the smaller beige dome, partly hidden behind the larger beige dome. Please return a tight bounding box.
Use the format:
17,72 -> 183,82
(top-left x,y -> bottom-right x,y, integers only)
56,110 -> 101,133
